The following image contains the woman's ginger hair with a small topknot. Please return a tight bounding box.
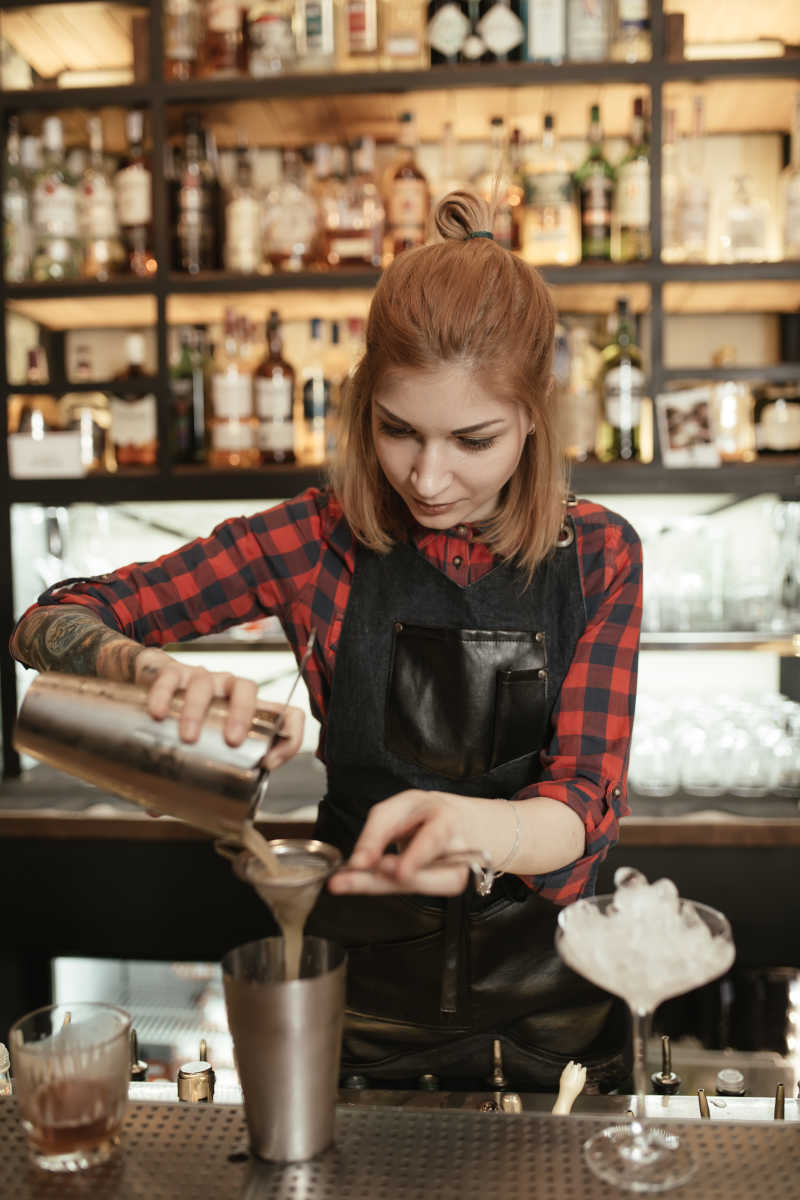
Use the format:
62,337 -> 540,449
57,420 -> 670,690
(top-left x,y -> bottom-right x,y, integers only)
331,191 -> 566,578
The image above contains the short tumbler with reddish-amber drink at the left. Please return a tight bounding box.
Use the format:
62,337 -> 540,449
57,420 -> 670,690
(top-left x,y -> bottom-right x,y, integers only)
8,1002 -> 131,1171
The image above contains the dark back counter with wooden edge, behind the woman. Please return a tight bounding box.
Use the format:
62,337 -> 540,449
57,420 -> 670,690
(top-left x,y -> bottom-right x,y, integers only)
0,755 -> 800,1030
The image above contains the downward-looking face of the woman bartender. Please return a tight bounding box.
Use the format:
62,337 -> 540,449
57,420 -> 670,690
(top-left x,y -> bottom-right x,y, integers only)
372,365 -> 530,529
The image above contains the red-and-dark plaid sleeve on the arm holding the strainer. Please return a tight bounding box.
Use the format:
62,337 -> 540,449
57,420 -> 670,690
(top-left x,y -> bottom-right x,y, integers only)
515,502 -> 642,905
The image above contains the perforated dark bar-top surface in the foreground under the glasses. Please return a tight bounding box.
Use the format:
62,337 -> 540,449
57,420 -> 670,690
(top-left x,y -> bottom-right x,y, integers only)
0,1099 -> 800,1200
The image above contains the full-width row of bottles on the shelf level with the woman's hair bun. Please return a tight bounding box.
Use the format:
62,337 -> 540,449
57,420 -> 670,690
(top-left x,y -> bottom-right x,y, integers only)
4,91 -> 800,282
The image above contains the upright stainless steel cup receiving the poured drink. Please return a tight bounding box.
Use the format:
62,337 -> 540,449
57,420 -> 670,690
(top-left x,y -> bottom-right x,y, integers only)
222,937 -> 345,1163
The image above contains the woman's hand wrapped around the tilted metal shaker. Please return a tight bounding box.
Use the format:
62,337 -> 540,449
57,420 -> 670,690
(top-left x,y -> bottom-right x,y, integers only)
136,648 -> 306,770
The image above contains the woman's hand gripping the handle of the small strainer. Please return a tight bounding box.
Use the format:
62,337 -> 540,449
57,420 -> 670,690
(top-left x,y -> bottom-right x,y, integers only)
329,790 -> 498,896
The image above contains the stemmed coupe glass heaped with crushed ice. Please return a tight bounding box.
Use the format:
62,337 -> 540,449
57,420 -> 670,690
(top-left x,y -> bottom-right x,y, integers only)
555,868 -> 735,1193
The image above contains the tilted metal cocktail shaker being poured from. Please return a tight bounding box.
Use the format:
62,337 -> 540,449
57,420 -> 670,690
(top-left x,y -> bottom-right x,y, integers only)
14,671 -> 283,838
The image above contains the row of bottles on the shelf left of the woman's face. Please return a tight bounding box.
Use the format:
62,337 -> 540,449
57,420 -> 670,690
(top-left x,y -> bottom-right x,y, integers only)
8,308 -> 363,479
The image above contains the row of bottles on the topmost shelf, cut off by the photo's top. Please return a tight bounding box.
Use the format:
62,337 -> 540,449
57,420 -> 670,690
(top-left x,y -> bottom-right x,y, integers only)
159,0 -> 651,79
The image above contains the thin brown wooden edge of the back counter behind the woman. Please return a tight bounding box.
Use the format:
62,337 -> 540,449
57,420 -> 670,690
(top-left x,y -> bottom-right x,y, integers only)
0,808 -> 800,846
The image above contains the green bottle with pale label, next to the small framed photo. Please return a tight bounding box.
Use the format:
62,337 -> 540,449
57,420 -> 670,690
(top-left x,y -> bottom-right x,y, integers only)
597,298 -> 645,462
